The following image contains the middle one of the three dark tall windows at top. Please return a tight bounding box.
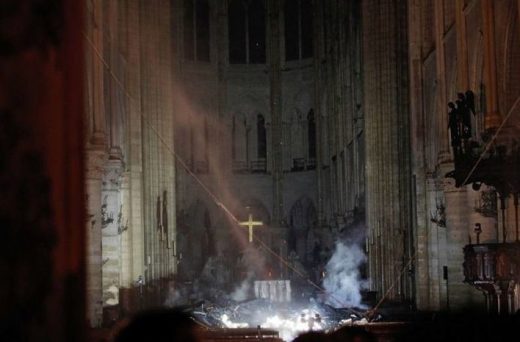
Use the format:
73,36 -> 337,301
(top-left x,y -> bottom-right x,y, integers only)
228,0 -> 266,64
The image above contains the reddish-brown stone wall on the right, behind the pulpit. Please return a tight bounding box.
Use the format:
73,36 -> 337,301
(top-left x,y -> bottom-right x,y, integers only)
408,0 -> 519,310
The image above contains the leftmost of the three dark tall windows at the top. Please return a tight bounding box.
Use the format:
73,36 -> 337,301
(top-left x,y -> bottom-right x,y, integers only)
184,0 -> 209,62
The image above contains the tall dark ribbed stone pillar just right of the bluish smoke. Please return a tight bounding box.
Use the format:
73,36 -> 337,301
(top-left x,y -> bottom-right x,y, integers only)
363,0 -> 411,300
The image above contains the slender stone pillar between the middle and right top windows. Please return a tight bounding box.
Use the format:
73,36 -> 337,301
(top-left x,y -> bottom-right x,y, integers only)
268,0 -> 284,225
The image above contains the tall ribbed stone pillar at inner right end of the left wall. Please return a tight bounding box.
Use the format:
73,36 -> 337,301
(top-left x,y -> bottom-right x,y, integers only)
139,0 -> 175,294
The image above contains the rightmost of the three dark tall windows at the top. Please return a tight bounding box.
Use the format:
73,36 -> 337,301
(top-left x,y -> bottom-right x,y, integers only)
284,0 -> 313,61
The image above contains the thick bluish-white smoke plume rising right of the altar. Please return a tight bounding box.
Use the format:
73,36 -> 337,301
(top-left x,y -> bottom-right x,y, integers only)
323,241 -> 367,308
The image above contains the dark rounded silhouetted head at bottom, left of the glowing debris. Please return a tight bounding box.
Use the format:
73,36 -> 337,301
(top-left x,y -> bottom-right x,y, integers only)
114,309 -> 201,342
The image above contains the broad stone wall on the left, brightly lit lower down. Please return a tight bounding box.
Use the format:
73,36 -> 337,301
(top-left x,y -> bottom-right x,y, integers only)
84,0 -> 175,326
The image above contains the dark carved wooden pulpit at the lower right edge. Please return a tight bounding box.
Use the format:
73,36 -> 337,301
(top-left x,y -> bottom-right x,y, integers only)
464,242 -> 520,313
